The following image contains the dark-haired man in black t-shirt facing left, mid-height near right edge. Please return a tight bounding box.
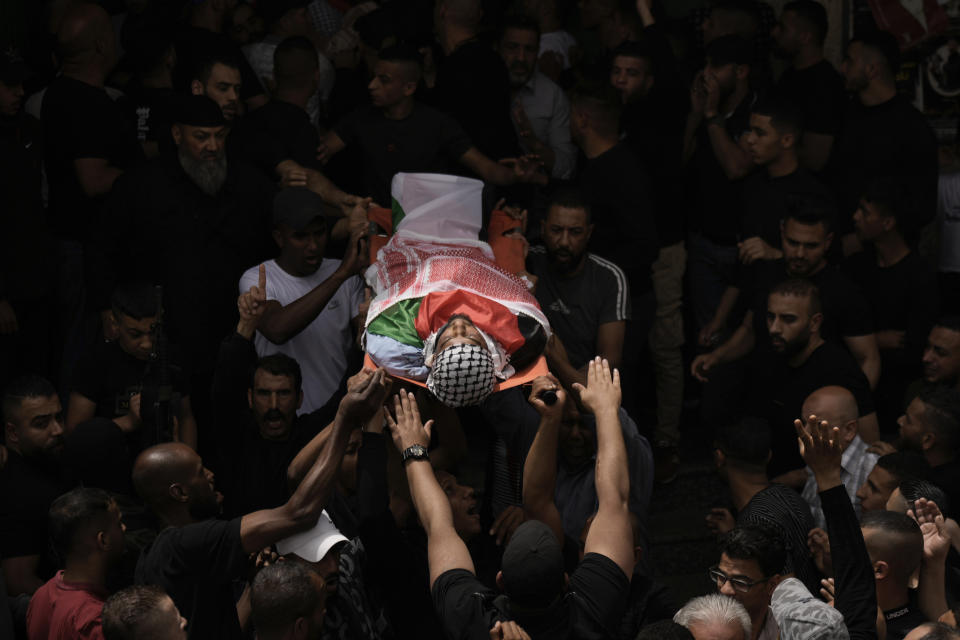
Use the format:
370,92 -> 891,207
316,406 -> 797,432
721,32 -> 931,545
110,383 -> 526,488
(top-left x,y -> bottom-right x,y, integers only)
843,178 -> 939,431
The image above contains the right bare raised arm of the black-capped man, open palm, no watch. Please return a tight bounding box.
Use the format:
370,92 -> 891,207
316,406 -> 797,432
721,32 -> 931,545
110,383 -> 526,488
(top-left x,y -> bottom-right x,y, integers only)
574,358 -> 634,578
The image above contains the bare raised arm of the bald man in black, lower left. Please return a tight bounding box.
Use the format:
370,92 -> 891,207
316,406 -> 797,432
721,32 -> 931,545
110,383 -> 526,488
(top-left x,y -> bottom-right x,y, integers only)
240,369 -> 387,553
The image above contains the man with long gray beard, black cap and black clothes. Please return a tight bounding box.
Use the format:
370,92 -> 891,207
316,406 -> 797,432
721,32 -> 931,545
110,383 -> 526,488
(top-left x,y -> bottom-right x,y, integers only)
88,96 -> 273,444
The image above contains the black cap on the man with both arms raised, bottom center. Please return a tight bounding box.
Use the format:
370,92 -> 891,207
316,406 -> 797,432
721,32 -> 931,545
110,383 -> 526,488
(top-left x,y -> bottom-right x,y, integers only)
500,520 -> 563,608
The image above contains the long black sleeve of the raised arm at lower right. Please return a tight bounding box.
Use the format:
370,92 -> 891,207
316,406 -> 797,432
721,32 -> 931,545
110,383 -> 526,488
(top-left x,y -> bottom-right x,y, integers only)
820,485 -> 877,640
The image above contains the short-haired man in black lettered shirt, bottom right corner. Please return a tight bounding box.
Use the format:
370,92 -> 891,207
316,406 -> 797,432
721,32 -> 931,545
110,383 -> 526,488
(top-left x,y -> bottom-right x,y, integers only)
860,511 -> 926,640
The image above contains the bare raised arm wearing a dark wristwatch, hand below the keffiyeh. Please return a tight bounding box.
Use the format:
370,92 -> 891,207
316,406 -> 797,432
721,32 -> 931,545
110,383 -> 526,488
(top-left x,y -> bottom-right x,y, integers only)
385,392 -> 476,590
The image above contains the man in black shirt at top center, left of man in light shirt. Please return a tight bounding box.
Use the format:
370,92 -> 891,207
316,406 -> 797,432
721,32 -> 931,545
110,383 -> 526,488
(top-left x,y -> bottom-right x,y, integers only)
425,0 -> 519,160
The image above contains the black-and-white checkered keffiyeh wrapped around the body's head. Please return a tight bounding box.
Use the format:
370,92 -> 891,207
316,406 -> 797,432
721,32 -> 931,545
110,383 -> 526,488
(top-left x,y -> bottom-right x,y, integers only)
427,344 -> 496,408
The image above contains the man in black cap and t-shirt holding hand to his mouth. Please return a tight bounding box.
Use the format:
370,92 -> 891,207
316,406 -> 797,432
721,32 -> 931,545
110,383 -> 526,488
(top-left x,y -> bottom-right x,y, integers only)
683,35 -> 756,328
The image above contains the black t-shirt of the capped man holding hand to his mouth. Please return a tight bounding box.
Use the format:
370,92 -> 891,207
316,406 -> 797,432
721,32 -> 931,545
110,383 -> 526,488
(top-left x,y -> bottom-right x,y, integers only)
688,94 -> 756,245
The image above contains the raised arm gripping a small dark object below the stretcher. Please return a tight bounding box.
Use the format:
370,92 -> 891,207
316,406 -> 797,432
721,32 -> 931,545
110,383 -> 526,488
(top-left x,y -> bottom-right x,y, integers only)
523,375 -> 567,543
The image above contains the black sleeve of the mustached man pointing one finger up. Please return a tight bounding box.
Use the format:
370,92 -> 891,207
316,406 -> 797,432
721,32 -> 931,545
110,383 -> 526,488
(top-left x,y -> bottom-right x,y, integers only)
212,333 -> 257,452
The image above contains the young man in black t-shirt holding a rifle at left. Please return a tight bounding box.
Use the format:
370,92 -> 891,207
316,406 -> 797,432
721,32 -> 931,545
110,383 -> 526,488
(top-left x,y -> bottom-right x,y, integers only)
67,283 -> 197,455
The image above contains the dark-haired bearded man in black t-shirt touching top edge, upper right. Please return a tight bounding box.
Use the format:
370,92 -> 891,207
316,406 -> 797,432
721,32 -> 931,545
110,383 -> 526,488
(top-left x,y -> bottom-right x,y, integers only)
772,0 -> 847,171
